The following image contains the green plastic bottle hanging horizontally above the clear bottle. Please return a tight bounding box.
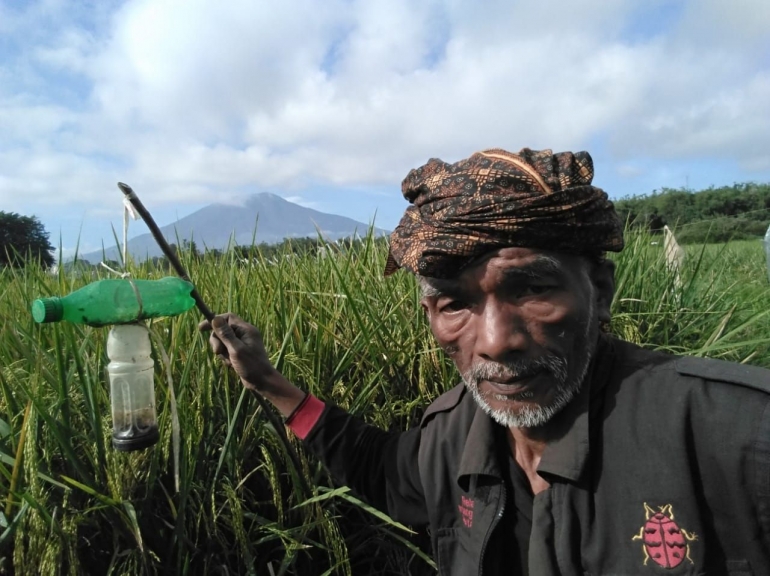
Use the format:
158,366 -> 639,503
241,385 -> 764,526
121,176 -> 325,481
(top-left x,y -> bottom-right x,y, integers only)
32,276 -> 195,326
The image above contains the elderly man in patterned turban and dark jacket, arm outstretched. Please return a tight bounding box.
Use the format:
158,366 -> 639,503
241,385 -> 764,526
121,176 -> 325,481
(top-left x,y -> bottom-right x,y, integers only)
201,148 -> 770,576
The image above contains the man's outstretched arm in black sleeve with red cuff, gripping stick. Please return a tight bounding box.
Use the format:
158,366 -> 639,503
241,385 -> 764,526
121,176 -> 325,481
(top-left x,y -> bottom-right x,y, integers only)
199,314 -> 428,525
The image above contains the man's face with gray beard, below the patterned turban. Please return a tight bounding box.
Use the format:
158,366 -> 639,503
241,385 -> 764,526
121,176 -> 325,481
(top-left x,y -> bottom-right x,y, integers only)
422,248 -> 611,428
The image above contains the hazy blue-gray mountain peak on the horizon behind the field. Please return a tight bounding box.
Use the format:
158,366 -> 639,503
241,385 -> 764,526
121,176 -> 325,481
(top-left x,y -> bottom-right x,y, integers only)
79,192 -> 388,263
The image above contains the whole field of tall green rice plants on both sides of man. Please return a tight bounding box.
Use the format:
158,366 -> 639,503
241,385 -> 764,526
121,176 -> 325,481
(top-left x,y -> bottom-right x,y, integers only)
0,236 -> 770,575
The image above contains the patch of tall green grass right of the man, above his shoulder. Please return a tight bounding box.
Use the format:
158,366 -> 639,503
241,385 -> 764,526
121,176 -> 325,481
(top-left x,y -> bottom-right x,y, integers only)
612,233 -> 770,367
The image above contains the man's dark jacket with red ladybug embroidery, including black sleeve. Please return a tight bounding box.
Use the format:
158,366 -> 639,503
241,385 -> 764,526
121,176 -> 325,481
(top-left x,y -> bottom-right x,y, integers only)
296,341 -> 770,576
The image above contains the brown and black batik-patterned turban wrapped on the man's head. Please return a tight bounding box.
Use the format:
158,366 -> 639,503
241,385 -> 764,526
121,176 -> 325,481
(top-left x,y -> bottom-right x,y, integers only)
385,148 -> 623,278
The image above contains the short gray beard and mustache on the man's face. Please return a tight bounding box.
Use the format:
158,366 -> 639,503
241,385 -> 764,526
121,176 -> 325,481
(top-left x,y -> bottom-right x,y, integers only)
463,306 -> 597,428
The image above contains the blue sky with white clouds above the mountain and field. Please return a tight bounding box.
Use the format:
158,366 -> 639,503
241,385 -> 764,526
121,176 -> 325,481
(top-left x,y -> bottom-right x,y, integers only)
0,0 -> 770,257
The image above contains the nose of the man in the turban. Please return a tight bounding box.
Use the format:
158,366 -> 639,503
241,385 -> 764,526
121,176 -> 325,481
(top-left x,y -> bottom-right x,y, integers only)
476,303 -> 530,361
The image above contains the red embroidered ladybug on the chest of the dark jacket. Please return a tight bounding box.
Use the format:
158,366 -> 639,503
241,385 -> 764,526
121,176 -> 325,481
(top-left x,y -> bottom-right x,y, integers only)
632,502 -> 698,568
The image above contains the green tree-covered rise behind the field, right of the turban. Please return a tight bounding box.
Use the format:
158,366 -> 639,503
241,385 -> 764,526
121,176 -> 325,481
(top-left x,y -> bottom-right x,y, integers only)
614,182 -> 770,244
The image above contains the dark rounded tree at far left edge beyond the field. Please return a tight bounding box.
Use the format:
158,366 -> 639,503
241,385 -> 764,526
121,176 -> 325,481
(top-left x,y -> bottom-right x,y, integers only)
0,211 -> 54,267
